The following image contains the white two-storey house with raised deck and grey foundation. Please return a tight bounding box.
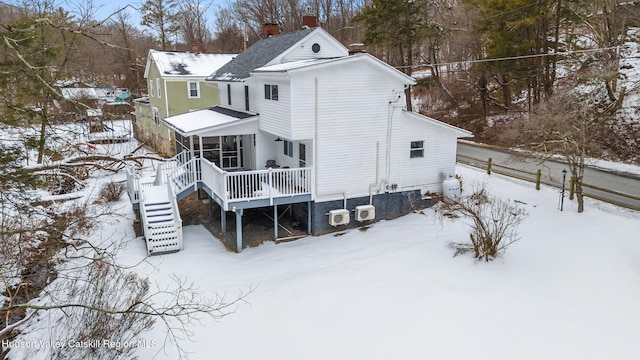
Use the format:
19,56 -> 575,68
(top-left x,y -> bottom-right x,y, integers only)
126,19 -> 472,255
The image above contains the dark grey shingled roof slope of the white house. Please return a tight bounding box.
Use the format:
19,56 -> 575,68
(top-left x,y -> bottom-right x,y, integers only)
207,28 -> 319,81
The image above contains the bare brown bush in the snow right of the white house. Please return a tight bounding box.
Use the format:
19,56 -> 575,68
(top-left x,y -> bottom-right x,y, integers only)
436,188 -> 527,261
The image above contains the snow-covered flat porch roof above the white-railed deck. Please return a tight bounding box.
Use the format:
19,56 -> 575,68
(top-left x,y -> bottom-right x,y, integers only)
162,106 -> 258,136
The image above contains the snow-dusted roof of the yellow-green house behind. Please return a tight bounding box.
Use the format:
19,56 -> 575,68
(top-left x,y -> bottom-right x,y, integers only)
144,49 -> 236,78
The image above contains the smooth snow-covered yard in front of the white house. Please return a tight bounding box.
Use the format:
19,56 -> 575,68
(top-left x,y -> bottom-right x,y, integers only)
112,166 -> 640,360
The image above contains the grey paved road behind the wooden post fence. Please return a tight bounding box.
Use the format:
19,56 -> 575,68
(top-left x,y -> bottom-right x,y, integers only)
458,142 -> 640,210
